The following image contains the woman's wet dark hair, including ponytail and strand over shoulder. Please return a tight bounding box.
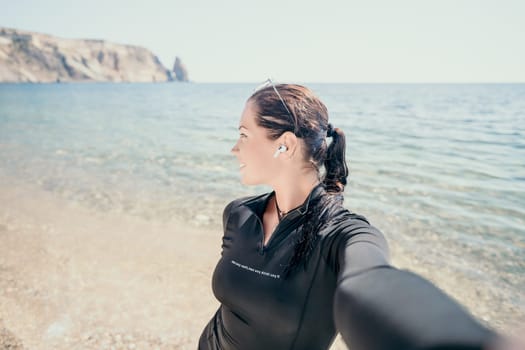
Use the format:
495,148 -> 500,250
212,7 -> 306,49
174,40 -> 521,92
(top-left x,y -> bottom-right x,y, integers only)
248,84 -> 348,273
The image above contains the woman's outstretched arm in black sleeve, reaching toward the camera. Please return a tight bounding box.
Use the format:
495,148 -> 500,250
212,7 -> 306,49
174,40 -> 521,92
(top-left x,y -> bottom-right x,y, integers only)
334,235 -> 496,350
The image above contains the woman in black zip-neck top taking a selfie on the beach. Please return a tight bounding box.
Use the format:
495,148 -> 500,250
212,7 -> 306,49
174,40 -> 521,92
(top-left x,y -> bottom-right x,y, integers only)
199,80 -> 494,350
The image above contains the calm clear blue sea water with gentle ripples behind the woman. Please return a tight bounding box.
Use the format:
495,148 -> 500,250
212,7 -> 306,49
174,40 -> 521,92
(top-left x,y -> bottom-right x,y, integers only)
0,83 -> 525,318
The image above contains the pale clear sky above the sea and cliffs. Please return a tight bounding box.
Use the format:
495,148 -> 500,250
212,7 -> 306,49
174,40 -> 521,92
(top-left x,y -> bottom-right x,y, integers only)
0,0 -> 525,83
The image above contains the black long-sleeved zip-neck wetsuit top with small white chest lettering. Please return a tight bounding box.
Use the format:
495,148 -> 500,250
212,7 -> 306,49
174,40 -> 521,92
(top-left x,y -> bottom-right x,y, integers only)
199,186 -> 493,350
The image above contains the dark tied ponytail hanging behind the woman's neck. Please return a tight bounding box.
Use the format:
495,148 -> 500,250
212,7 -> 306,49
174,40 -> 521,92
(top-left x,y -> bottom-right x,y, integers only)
323,124 -> 348,194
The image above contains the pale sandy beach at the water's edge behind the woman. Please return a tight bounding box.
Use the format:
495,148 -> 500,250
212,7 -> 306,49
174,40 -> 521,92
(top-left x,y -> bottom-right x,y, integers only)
0,185 -> 524,350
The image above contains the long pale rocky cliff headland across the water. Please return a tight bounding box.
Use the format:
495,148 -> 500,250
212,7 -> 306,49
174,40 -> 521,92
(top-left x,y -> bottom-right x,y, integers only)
0,28 -> 187,83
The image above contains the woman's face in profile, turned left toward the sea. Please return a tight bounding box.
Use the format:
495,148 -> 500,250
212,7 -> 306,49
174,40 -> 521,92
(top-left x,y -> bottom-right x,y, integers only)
231,101 -> 279,185
